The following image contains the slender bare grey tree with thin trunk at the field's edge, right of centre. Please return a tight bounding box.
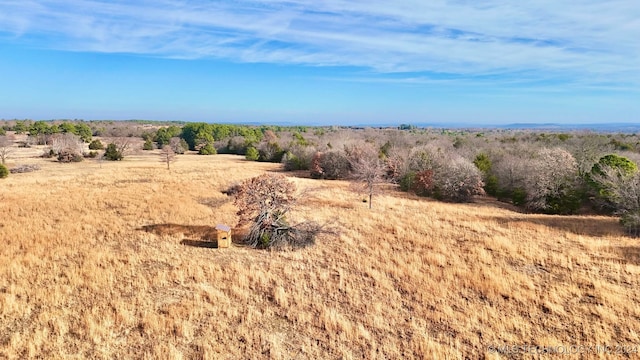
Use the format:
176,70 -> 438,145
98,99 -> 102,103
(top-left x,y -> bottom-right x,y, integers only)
350,146 -> 387,209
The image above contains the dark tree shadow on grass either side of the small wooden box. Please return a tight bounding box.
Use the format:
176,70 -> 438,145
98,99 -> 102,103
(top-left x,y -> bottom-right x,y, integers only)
138,224 -> 249,248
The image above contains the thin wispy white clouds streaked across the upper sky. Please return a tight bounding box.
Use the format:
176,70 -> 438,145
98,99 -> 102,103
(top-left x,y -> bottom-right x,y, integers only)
0,0 -> 640,87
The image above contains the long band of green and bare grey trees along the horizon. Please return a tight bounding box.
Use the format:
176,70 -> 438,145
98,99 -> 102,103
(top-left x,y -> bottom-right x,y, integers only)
0,120 -> 640,235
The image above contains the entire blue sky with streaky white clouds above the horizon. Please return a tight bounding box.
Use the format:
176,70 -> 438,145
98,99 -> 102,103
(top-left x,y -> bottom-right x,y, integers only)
0,0 -> 640,125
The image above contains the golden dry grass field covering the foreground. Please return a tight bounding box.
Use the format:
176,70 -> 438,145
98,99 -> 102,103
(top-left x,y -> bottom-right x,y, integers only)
0,145 -> 640,359
